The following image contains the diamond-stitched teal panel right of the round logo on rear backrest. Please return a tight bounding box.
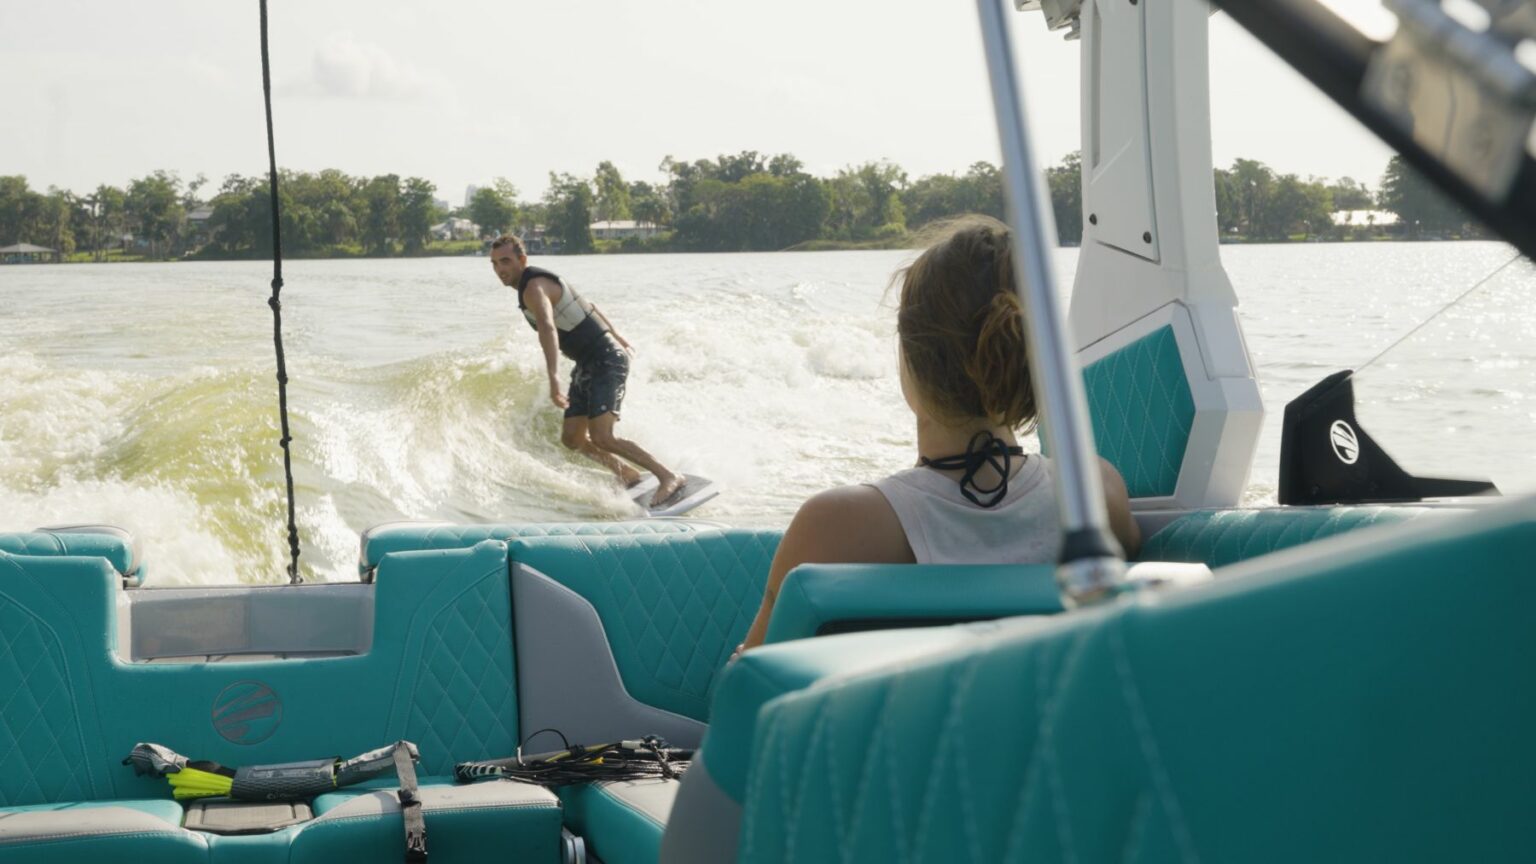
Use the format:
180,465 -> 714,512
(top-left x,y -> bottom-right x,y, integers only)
404,547 -> 518,775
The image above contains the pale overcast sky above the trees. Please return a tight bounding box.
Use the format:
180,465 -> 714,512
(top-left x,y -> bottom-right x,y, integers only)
0,0 -> 1389,204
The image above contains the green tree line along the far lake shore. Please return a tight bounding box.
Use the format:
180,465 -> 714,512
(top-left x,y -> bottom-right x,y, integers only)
0,151 -> 1475,260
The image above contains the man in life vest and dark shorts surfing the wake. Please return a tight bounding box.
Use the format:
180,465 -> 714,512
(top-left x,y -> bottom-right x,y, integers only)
490,234 -> 685,507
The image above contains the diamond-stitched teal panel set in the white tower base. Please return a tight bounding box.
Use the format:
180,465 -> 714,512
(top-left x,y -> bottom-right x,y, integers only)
1083,326 -> 1195,498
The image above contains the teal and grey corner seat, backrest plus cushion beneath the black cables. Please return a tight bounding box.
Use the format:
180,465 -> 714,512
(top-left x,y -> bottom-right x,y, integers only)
491,529 -> 780,864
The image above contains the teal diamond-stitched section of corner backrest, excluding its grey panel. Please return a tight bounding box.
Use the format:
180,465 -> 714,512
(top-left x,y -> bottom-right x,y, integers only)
511,530 -> 780,719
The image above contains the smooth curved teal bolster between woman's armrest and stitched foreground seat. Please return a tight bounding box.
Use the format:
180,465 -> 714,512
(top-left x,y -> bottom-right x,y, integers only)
694,627 -> 977,803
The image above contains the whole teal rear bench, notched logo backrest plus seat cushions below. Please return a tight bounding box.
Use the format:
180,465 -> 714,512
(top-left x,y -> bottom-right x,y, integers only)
0,541 -> 561,864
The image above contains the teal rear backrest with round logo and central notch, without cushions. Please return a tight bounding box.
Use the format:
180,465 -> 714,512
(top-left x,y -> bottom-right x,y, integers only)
0,541 -> 519,807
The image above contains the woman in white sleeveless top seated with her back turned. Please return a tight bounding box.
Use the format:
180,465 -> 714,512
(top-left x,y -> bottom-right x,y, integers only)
737,220 -> 1141,650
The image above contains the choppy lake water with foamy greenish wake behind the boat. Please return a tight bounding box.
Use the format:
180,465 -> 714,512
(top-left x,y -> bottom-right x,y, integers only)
0,243 -> 1536,584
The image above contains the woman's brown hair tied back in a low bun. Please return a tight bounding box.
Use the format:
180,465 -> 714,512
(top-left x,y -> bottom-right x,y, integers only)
895,217 -> 1035,429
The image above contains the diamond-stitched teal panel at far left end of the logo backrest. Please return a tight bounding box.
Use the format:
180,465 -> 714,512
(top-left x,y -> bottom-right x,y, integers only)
0,584 -> 95,807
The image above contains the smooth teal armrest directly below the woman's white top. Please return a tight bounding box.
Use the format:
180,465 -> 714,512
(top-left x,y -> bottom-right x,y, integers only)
766,564 -> 1061,643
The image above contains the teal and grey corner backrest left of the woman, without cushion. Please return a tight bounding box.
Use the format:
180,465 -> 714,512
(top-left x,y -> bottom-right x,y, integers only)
511,529 -> 780,731
